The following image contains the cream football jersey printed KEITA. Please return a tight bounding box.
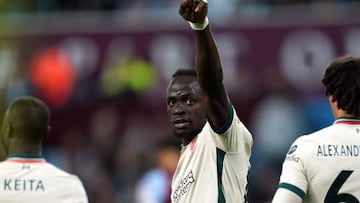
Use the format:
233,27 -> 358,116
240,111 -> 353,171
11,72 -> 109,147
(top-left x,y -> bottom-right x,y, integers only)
0,156 -> 88,203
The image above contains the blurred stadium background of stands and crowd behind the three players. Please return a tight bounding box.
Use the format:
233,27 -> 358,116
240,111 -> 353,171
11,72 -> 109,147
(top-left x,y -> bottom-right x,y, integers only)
0,0 -> 360,203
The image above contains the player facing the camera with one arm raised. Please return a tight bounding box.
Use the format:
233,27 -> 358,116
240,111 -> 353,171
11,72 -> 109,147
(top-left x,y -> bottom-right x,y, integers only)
166,0 -> 253,203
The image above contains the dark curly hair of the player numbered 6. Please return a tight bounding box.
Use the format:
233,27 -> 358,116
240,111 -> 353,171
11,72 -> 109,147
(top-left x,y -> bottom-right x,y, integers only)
322,55 -> 360,117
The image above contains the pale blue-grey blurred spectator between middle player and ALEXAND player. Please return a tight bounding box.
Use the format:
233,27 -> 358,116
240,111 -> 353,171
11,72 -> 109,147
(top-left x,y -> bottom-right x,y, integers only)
252,95 -> 304,164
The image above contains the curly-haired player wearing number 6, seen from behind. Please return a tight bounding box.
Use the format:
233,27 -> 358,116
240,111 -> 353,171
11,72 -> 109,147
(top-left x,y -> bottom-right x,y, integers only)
272,56 -> 360,203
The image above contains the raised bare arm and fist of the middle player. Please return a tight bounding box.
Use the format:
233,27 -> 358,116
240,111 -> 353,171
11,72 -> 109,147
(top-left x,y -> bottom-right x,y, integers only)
179,0 -> 230,129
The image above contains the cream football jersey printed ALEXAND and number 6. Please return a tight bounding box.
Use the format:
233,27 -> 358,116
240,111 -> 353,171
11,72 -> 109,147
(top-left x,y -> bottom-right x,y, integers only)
279,118 -> 360,203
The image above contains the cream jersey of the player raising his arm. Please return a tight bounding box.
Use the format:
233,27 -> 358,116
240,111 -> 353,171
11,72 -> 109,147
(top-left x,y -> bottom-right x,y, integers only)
171,108 -> 252,203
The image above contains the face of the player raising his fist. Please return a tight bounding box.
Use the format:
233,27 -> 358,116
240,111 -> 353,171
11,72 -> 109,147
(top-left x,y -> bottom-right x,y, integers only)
166,76 -> 206,145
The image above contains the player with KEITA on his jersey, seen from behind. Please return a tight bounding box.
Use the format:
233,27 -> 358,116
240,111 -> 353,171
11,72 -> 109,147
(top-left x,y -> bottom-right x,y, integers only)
0,96 -> 88,203
